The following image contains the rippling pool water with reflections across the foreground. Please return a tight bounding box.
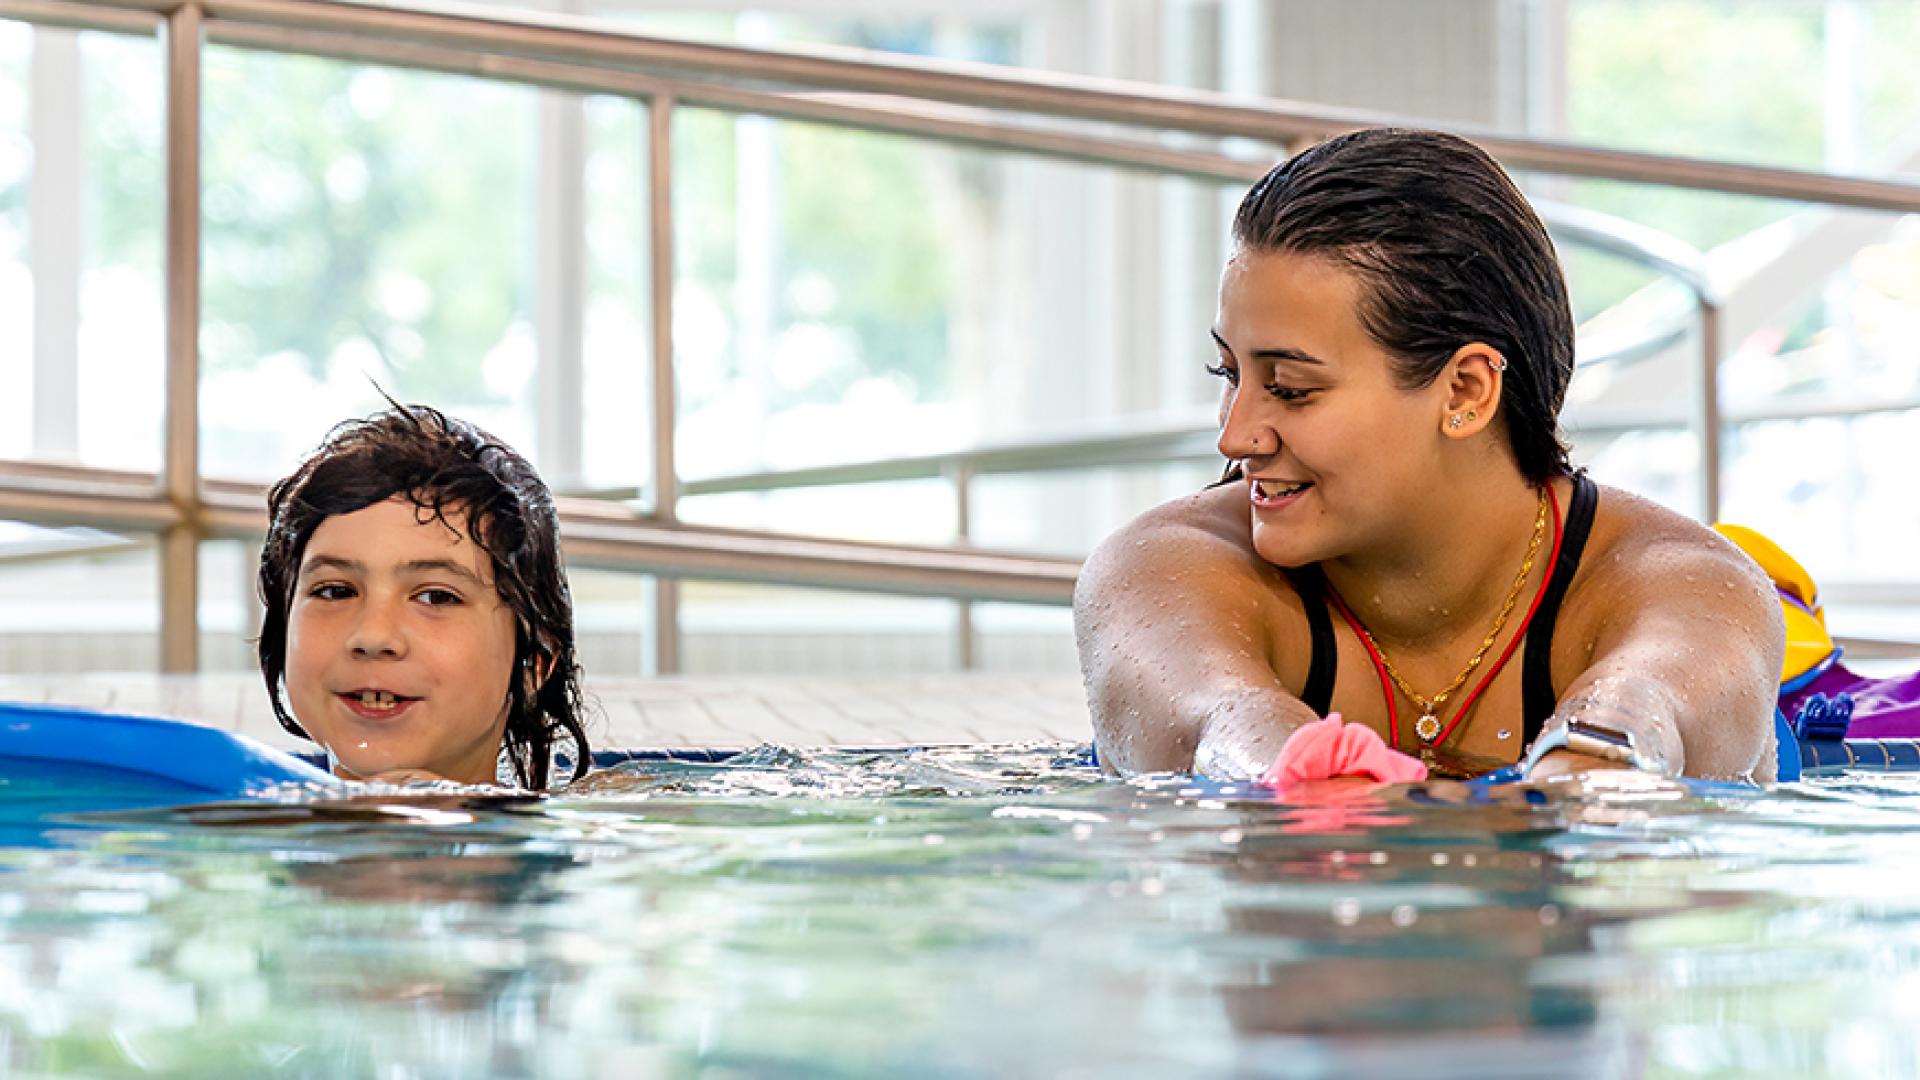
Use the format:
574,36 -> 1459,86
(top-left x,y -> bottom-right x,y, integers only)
0,746 -> 1920,1078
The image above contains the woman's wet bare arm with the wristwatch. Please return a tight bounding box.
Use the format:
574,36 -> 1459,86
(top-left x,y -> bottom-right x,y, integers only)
1536,523 -> 1786,780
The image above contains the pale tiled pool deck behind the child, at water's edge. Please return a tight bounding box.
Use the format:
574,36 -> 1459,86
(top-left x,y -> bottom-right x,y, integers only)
0,673 -> 1091,751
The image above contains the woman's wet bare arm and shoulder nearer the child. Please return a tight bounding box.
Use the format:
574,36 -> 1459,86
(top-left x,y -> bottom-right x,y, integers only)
1073,494 -> 1315,778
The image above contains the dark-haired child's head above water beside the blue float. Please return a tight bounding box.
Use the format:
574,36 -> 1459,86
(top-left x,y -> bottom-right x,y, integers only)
259,405 -> 589,790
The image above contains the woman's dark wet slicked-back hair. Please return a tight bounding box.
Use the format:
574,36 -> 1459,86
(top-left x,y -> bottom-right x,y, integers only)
1233,129 -> 1574,484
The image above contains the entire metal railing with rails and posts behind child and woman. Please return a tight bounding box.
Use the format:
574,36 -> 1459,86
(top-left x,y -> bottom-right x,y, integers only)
0,0 -> 1920,669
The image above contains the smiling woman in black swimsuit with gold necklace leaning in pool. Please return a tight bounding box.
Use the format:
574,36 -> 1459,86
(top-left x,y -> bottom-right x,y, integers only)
1075,131 -> 1784,780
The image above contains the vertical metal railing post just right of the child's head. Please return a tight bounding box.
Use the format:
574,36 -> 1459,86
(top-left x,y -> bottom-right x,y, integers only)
647,94 -> 680,675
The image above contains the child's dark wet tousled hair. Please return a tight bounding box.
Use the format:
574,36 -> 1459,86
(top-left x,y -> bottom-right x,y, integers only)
259,404 -> 591,788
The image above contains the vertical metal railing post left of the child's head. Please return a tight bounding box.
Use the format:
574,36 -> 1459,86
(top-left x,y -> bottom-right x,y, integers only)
159,4 -> 200,673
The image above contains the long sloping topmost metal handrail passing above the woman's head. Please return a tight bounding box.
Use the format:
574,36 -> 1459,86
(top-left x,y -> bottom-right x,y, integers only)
15,0 -> 1920,211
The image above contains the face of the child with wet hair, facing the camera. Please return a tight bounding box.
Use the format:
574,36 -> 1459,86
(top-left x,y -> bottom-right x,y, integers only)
286,496 -> 515,784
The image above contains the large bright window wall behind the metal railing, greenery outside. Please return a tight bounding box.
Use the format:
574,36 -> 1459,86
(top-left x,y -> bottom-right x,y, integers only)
0,0 -> 1920,673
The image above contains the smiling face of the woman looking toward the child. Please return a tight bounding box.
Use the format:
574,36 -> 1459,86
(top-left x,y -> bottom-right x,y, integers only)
1213,250 -> 1446,567
